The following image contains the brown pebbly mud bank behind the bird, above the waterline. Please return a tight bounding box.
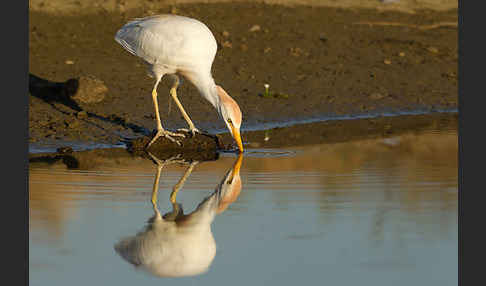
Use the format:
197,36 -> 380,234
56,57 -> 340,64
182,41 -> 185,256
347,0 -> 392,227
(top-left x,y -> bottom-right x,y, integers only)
29,3 -> 457,150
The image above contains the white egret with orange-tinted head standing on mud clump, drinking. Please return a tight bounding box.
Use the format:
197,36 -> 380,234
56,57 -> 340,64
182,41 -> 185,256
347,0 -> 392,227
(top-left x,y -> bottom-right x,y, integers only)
115,15 -> 243,152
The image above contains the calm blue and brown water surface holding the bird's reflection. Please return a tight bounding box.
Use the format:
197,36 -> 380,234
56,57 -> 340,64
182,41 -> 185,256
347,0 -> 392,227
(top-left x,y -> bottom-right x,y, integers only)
29,130 -> 458,286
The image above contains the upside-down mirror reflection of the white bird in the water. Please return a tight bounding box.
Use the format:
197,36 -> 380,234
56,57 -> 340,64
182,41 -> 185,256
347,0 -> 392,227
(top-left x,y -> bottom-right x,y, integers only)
115,154 -> 243,277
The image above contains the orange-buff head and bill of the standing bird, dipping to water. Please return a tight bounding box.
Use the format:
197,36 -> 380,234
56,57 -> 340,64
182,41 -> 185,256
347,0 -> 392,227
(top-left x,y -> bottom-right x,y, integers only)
216,85 -> 243,152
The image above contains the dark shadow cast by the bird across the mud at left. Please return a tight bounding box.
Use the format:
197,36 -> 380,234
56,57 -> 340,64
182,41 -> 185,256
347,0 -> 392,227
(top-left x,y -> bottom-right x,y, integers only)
29,73 -> 151,135
